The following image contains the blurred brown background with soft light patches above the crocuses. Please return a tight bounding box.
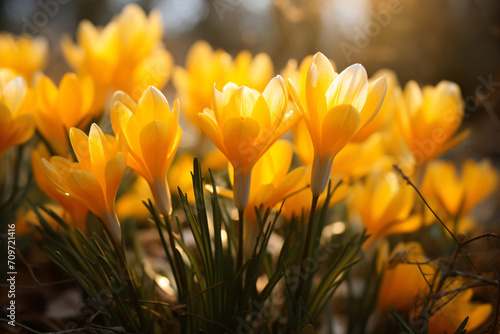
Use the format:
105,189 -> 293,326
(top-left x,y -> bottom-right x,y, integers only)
0,0 -> 500,160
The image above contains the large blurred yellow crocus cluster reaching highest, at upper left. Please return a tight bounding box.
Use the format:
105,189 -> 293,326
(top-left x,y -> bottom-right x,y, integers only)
62,4 -> 173,103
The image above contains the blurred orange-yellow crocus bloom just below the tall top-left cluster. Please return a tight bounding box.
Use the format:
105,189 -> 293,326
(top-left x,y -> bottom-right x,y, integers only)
35,73 -> 96,155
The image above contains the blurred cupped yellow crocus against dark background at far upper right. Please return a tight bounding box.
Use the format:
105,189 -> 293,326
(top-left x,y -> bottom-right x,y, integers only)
398,81 -> 469,165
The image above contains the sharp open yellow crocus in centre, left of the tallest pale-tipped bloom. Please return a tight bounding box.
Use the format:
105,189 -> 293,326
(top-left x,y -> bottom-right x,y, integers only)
199,76 -> 295,211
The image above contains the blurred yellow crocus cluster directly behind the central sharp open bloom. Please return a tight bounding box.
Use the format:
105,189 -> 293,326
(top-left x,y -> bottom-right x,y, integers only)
173,41 -> 274,135
